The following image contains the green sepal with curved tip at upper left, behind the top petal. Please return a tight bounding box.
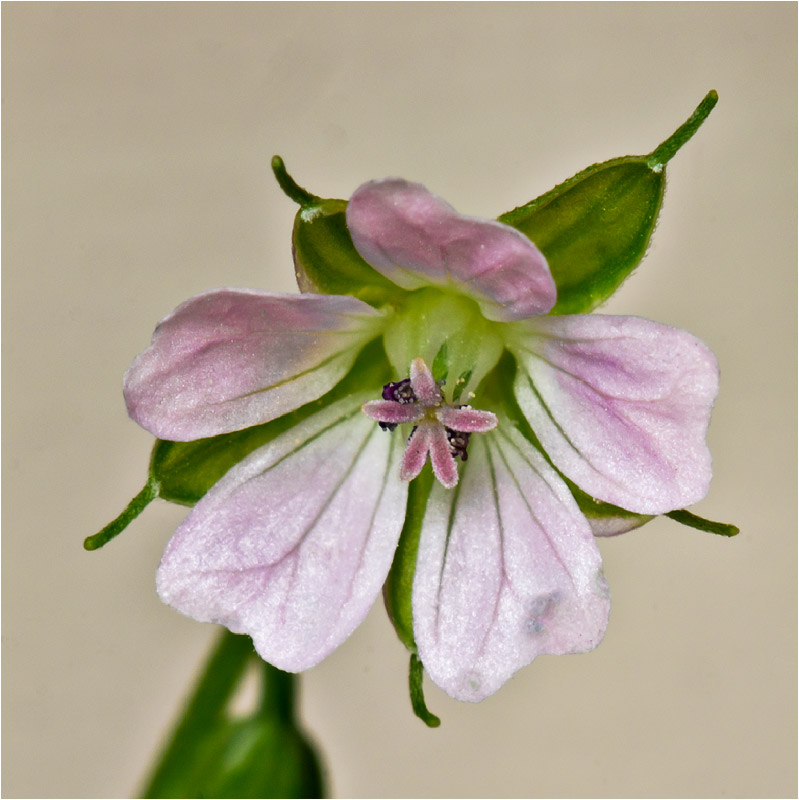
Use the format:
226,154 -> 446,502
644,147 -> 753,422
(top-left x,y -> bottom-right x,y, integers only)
272,156 -> 404,307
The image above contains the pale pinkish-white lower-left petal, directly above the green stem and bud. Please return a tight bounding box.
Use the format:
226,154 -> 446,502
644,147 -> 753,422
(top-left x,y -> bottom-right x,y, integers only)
157,396 -> 407,672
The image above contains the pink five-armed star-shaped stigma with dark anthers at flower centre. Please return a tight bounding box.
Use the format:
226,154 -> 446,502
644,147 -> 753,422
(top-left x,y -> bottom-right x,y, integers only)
362,358 -> 497,489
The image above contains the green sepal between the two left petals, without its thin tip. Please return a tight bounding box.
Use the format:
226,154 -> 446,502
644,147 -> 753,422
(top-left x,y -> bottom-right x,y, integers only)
150,339 -> 391,505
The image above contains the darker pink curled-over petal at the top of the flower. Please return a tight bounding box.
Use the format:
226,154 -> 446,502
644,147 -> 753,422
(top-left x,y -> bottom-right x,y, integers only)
347,178 -> 557,321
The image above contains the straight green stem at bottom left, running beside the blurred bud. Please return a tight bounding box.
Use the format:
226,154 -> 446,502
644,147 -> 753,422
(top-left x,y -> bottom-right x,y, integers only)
141,630 -> 253,797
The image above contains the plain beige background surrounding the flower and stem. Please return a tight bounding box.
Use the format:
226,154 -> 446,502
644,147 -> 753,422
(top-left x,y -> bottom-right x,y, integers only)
2,3 -> 797,797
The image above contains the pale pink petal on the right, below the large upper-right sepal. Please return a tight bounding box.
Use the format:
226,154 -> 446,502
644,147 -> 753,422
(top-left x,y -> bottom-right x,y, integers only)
511,315 -> 718,514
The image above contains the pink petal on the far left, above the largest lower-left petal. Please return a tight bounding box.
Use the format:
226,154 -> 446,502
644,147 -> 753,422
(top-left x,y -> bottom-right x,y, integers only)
124,289 -> 382,441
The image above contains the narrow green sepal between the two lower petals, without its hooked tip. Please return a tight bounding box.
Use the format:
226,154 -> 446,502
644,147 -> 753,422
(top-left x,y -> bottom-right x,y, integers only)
383,466 -> 433,653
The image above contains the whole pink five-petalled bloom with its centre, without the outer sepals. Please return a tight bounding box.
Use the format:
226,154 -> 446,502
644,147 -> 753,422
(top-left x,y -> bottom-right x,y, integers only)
125,179 -> 718,701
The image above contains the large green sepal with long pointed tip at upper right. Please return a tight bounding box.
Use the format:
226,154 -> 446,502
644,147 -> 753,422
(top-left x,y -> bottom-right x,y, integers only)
499,91 -> 718,314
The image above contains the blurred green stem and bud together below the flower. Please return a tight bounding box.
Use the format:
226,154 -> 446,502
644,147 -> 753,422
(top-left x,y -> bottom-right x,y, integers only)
142,631 -> 323,798
